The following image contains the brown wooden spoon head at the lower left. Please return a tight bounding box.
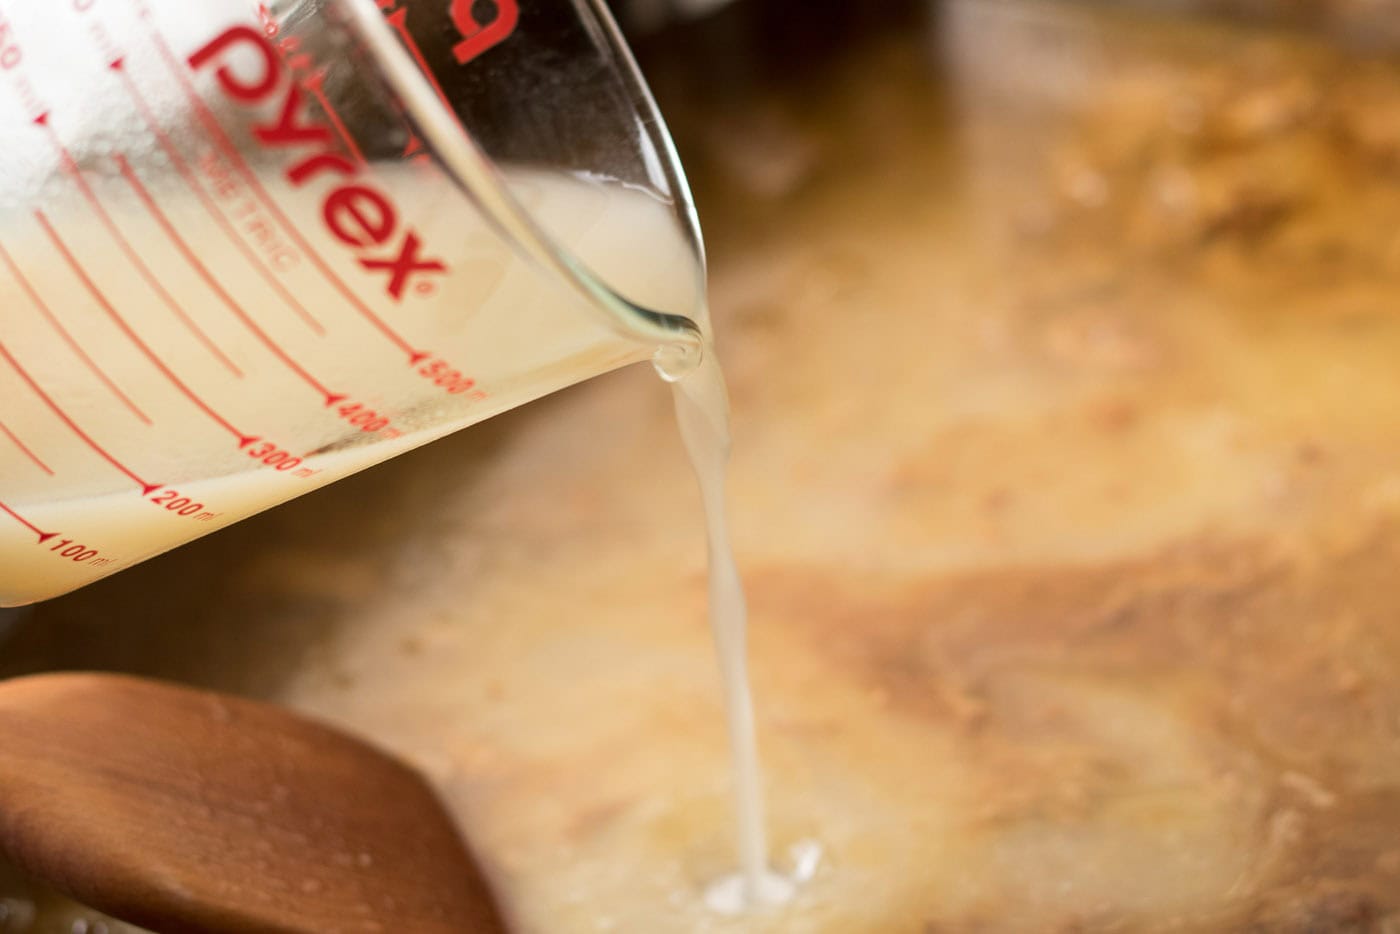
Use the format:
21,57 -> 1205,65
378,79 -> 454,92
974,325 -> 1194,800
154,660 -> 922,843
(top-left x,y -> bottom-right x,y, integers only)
0,675 -> 505,934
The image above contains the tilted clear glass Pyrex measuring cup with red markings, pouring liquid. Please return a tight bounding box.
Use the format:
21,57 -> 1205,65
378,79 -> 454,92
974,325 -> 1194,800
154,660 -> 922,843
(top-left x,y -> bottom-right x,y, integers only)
0,0 -> 703,605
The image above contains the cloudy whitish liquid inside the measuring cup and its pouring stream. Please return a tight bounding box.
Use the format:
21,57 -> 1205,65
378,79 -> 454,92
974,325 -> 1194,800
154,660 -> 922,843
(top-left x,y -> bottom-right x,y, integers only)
0,168 -> 792,912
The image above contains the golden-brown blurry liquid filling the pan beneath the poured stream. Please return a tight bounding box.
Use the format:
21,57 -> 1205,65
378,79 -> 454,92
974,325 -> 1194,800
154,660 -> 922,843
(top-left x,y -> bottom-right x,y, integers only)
11,0 -> 1400,934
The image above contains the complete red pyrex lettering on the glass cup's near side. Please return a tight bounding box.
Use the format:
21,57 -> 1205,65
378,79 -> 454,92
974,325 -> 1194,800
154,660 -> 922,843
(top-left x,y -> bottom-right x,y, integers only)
189,25 -> 447,301
